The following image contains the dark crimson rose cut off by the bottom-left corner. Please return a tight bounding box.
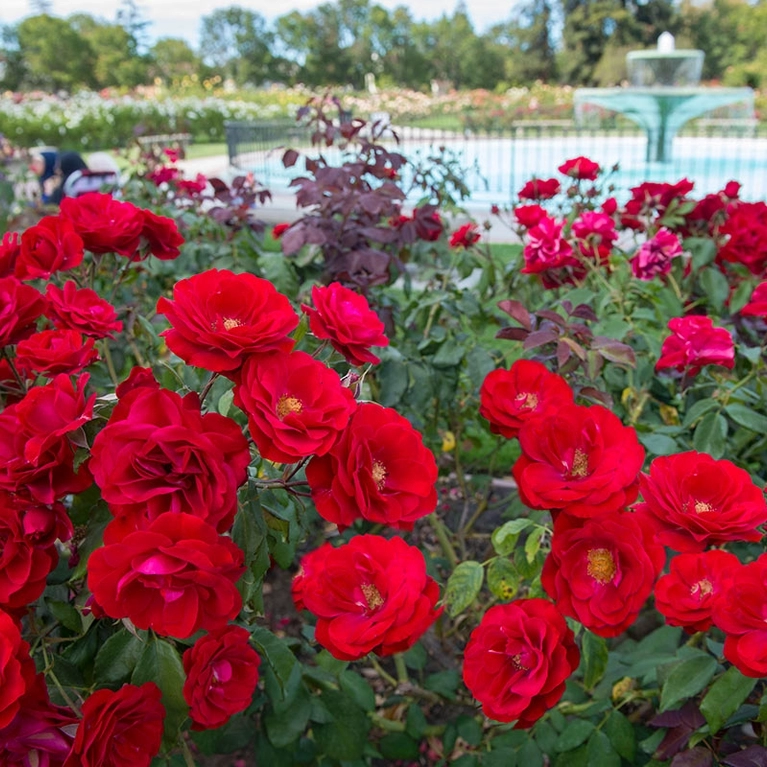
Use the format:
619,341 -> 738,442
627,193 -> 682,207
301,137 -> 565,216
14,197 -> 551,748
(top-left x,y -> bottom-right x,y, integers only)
0,674 -> 80,767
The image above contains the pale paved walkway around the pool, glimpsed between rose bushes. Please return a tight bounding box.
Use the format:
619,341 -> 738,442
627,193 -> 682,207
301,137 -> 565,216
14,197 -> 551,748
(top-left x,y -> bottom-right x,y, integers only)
178,155 -> 519,243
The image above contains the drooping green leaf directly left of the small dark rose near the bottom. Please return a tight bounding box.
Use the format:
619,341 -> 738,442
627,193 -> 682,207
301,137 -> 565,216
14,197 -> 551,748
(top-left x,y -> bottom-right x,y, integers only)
131,639 -> 189,744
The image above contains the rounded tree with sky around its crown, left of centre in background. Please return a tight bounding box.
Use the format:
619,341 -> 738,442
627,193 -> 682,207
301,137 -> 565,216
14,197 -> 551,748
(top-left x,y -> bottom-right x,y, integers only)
200,5 -> 274,85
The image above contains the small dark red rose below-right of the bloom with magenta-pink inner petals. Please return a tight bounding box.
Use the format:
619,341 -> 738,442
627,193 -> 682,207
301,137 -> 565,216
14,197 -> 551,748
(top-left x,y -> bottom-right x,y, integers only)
184,626 -> 260,730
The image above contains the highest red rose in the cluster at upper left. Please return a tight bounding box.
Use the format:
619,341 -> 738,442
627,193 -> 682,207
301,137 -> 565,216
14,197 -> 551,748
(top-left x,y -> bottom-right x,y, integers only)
60,192 -> 144,258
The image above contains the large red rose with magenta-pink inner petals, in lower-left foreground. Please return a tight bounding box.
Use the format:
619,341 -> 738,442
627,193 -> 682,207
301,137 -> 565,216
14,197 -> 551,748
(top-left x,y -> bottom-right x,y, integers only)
88,514 -> 245,639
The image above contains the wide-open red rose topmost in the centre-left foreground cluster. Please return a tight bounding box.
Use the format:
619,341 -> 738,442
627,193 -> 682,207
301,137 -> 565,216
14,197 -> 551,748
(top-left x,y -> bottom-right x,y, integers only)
157,269 -> 298,373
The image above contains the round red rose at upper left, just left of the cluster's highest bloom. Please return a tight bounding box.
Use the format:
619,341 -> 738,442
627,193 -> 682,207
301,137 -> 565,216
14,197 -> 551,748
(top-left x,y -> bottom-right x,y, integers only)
15,216 -> 83,280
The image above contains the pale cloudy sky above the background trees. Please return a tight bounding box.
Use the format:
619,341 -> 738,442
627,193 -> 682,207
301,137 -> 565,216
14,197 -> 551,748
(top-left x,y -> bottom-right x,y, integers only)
0,0 -> 512,48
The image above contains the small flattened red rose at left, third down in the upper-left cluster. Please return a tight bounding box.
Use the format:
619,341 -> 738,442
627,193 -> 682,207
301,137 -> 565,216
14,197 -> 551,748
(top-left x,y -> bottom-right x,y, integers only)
16,330 -> 99,378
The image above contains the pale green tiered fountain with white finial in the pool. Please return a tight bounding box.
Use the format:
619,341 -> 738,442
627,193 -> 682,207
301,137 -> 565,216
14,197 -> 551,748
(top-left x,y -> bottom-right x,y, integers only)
575,32 -> 754,163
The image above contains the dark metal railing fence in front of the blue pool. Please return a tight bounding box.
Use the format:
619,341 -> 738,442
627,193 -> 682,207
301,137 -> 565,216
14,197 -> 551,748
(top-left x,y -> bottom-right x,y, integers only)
226,119 -> 767,207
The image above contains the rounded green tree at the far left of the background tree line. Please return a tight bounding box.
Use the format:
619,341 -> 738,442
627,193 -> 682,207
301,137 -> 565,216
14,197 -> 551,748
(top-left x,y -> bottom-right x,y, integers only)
18,14 -> 96,90
